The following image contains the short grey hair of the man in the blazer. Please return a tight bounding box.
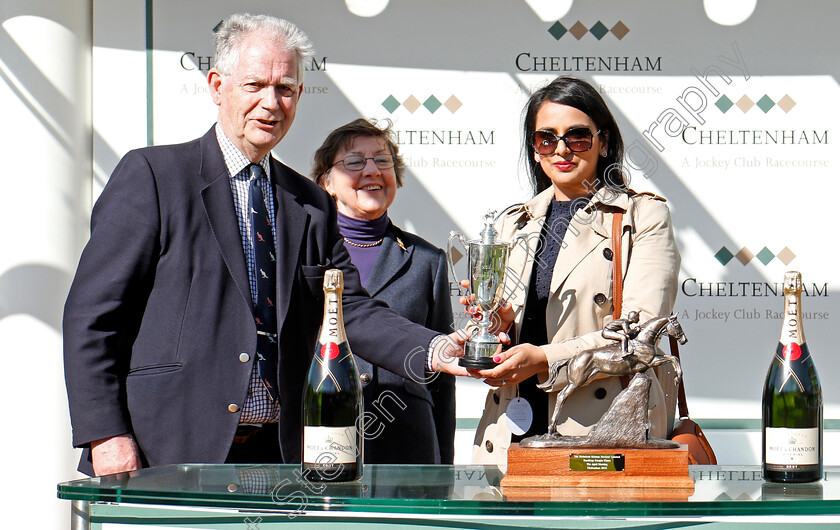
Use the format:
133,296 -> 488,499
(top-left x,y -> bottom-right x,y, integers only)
215,13 -> 315,85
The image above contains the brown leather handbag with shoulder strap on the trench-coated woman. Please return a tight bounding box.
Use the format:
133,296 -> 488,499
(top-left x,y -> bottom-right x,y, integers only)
612,211 -> 717,465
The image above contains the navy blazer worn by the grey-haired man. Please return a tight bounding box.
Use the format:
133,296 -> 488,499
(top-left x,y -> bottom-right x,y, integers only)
64,128 -> 436,474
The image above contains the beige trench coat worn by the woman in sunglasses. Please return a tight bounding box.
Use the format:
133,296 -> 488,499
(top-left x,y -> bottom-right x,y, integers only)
473,188 -> 680,470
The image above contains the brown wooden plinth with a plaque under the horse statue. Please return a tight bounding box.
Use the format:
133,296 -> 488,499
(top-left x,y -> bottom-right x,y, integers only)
501,438 -> 694,490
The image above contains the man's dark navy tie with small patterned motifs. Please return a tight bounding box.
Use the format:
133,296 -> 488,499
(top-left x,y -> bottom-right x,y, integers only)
248,164 -> 277,401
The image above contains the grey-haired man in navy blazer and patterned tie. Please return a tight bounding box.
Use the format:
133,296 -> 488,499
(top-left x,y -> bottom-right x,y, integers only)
64,15 -> 463,475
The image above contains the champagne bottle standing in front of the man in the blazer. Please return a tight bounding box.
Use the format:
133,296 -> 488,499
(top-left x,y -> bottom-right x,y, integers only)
301,269 -> 363,482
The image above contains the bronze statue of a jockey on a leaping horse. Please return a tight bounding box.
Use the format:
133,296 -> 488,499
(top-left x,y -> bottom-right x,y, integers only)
520,311 -> 687,448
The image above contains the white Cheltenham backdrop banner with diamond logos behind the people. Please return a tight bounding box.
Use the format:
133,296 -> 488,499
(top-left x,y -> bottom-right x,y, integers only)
94,0 -> 840,418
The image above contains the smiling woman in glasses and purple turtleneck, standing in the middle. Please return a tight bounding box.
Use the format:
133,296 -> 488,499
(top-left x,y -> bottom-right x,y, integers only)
312,119 -> 455,464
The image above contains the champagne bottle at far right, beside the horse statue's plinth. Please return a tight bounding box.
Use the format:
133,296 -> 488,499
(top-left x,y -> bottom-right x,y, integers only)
761,272 -> 823,482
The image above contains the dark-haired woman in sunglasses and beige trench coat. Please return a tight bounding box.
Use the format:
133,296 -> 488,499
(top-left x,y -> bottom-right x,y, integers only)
470,77 -> 680,468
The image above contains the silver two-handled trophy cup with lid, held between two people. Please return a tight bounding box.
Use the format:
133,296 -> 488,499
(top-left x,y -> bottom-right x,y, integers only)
446,211 -> 527,370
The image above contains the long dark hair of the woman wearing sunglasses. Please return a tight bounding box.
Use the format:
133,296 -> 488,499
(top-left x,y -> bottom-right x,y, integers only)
522,77 -> 626,195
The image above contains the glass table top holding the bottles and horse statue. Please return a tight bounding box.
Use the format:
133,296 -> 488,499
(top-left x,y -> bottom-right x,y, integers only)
58,464 -> 840,517
